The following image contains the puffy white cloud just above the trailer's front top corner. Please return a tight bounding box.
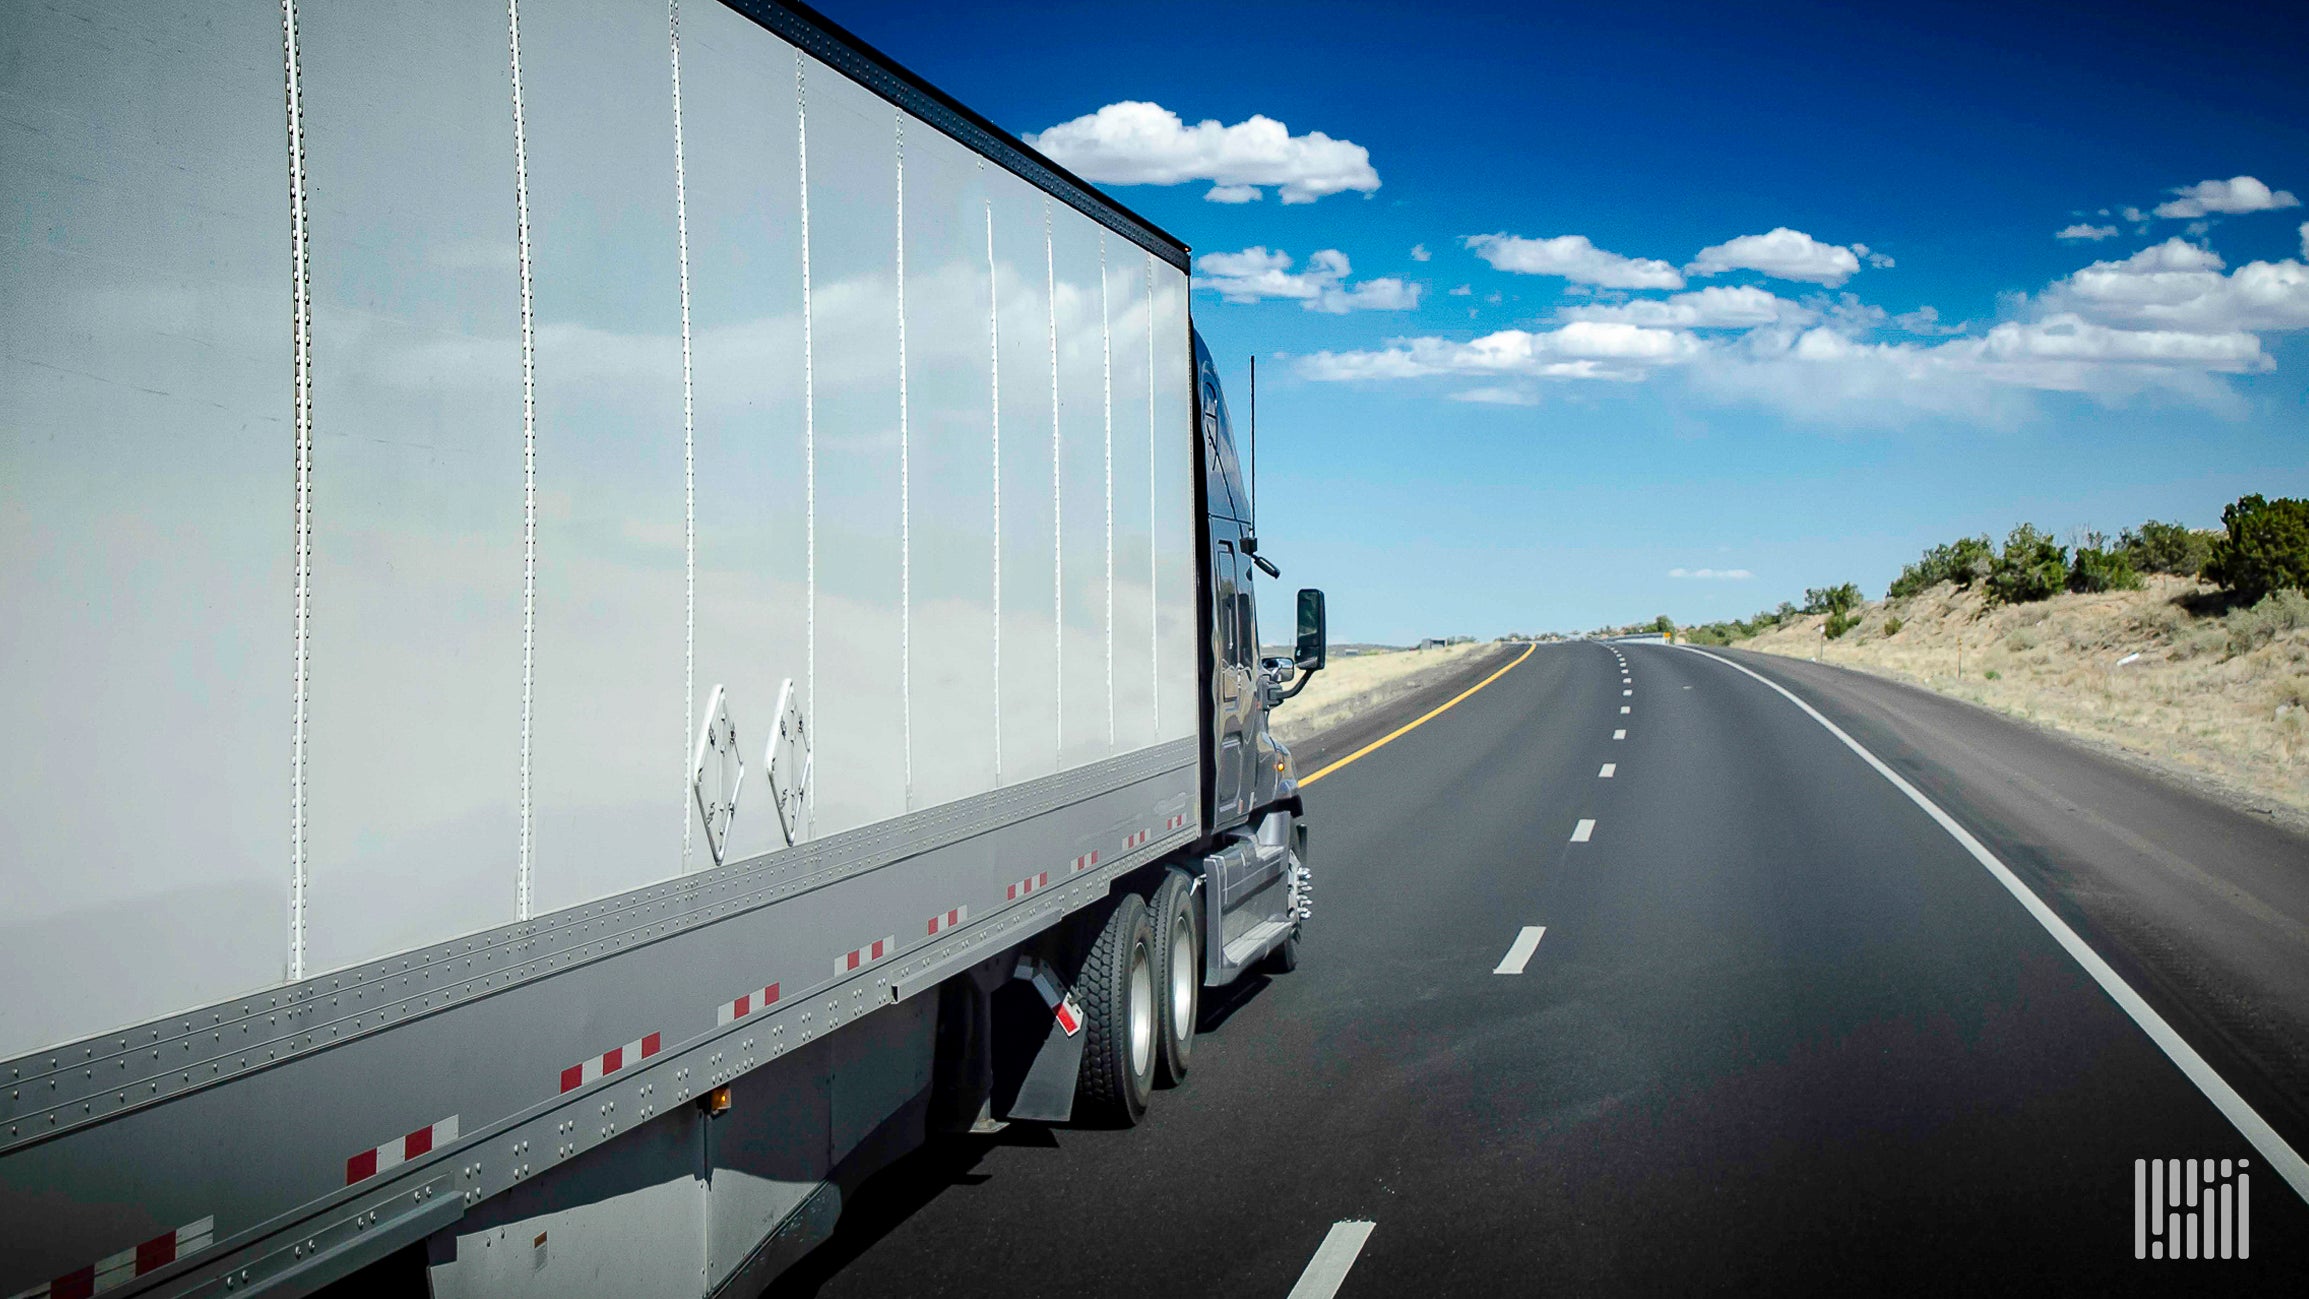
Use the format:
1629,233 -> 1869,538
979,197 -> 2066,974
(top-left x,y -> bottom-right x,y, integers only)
1025,99 -> 1378,203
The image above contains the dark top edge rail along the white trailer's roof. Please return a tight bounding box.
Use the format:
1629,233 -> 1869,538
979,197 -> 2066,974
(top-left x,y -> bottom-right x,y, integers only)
720,0 -> 1194,270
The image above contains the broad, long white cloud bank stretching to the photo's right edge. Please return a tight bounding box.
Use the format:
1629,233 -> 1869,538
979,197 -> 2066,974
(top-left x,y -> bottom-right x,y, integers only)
1298,224 -> 2309,427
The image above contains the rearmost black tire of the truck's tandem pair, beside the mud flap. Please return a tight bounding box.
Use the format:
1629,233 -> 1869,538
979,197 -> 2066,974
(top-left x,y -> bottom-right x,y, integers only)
1074,893 -> 1161,1128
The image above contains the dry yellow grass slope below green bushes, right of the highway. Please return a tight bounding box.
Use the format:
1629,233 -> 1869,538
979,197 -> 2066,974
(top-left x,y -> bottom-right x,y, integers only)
1741,577 -> 2309,814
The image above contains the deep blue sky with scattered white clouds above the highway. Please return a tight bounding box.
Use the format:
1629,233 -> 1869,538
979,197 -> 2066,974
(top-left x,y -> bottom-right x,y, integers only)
829,2 -> 2309,641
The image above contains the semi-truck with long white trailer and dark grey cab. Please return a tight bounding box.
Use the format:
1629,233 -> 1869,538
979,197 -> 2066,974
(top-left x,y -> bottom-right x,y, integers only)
0,0 -> 1325,1299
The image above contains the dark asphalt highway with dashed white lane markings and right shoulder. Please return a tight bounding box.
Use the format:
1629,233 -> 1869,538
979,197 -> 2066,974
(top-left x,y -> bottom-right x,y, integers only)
776,644 -> 2309,1299
